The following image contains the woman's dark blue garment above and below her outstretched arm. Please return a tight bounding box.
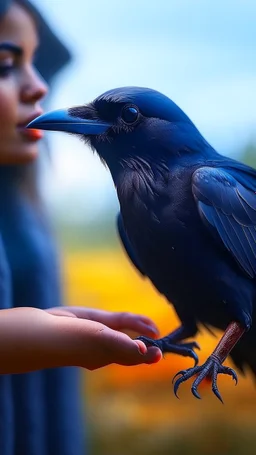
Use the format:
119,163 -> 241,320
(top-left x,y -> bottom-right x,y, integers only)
0,175 -> 85,455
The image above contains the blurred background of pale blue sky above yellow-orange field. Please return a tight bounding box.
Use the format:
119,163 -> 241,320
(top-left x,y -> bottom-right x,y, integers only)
34,0 -> 256,455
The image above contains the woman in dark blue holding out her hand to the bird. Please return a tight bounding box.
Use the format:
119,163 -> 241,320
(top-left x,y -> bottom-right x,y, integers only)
0,0 -> 159,455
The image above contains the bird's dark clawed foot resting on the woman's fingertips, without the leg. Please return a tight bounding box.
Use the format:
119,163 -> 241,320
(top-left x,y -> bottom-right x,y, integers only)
136,336 -> 200,366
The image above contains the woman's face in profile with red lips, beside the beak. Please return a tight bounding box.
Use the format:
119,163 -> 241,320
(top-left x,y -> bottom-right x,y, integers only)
0,3 -> 47,165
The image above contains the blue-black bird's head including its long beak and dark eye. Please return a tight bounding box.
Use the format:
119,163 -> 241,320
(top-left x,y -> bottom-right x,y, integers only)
28,87 -> 212,179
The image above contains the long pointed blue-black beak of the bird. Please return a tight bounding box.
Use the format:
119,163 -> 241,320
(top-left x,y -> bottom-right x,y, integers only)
27,110 -> 111,136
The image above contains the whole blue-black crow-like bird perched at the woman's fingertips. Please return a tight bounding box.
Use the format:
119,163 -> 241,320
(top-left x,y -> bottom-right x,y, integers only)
28,87 -> 256,401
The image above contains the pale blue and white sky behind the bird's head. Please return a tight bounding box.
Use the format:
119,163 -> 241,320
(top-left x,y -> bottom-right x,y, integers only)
33,0 -> 256,222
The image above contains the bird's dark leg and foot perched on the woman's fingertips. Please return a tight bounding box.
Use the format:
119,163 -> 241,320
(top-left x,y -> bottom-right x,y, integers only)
137,323 -> 200,365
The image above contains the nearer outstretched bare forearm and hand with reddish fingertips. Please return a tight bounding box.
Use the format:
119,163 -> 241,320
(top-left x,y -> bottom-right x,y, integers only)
0,307 -> 162,374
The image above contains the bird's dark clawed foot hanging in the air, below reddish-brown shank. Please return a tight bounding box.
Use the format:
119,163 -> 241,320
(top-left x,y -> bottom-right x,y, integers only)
173,355 -> 238,403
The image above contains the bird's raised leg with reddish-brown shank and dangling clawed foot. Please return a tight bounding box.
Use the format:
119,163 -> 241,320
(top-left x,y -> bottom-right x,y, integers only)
173,322 -> 245,402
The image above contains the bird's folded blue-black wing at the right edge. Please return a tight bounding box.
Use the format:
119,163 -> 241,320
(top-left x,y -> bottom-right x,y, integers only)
192,167 -> 256,278
